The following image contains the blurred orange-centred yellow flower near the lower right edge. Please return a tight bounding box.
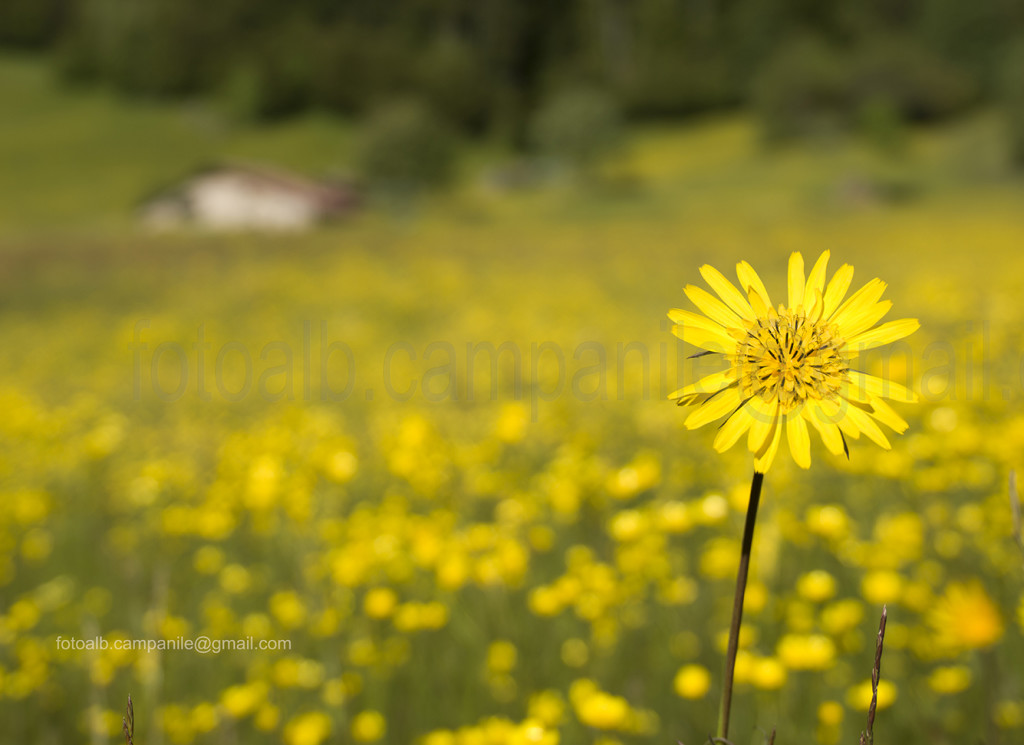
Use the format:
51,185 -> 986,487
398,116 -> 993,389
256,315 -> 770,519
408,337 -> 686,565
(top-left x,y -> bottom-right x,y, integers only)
928,579 -> 1004,650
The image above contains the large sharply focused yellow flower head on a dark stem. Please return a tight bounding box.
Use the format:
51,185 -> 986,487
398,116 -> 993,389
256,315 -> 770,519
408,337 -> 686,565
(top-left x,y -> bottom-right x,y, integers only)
669,251 -> 920,473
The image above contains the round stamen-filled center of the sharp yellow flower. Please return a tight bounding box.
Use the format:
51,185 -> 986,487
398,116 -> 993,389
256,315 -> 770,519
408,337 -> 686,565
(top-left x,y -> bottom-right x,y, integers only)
732,308 -> 849,413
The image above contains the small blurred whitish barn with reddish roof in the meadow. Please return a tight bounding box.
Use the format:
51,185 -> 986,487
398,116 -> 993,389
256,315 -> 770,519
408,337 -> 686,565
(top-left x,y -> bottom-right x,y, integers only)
138,164 -> 357,230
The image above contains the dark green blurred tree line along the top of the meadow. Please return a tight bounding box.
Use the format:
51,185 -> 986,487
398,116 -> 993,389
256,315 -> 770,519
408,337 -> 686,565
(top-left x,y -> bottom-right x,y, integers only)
0,0 -> 1024,147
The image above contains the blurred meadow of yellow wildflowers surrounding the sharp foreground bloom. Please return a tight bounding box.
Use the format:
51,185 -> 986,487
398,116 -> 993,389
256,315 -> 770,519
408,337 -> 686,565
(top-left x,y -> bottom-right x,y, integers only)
0,85 -> 1024,745
